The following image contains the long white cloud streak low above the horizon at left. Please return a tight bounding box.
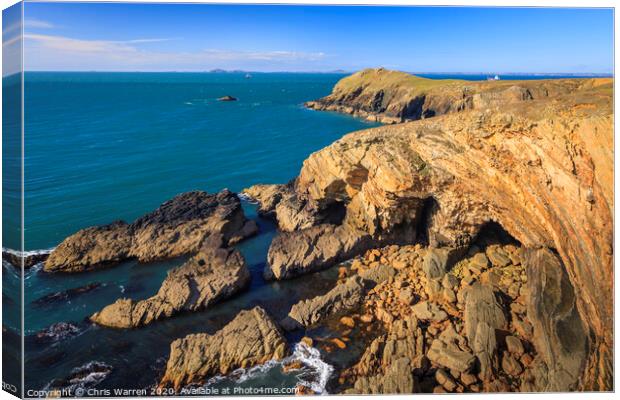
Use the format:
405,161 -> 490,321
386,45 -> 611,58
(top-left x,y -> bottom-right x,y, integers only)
24,33 -> 326,71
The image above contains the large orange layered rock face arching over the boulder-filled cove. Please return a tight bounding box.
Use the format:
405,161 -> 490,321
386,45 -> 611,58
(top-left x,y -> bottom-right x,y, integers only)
264,70 -> 614,390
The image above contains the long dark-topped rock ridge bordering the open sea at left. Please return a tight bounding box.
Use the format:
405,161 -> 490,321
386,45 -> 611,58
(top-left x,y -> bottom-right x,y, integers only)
44,189 -> 257,272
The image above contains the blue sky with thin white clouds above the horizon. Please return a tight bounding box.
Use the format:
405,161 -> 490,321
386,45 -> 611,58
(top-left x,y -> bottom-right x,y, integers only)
24,3 -> 613,73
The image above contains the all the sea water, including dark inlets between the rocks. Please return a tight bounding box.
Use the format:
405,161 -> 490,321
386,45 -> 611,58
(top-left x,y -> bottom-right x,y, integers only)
3,72 -> 604,394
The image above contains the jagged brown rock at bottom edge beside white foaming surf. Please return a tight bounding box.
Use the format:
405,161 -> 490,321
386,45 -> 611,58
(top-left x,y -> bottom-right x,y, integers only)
160,307 -> 289,389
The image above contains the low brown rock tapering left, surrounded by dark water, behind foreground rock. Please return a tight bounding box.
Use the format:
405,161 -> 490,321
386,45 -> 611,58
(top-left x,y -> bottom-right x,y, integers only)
90,234 -> 250,328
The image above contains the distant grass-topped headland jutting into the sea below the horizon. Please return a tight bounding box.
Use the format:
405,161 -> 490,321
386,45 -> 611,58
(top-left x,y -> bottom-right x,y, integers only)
306,68 -> 604,124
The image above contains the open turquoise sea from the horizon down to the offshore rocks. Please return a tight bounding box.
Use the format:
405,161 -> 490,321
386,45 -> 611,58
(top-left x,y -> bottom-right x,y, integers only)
24,73 -> 382,250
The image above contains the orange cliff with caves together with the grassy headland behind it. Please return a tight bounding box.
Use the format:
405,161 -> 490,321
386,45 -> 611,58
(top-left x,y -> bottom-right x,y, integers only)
248,69 -> 614,390
